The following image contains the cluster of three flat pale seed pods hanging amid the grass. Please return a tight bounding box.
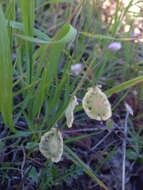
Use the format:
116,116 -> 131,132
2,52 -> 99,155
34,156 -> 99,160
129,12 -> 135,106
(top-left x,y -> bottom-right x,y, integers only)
39,87 -> 112,162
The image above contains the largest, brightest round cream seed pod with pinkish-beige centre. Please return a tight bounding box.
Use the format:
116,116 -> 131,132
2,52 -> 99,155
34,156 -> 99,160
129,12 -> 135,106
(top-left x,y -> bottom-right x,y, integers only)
82,87 -> 112,121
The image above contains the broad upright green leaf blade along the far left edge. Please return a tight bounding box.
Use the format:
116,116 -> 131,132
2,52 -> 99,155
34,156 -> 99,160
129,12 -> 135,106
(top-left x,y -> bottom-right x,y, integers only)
0,6 -> 15,132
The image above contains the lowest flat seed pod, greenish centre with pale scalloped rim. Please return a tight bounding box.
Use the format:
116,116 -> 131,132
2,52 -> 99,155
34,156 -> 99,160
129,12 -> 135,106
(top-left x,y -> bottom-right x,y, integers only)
39,128 -> 63,162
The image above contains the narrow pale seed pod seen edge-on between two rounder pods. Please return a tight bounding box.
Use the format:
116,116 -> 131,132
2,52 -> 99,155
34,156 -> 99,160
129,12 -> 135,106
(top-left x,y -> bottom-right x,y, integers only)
65,96 -> 78,128
